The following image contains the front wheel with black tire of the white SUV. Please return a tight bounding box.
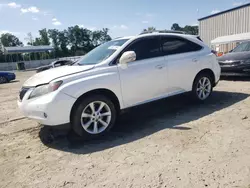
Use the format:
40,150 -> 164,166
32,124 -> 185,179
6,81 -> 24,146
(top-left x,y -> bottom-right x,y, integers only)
71,95 -> 117,139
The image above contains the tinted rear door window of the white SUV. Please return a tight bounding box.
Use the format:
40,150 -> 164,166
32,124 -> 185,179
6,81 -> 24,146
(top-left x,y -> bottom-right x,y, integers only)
162,37 -> 202,55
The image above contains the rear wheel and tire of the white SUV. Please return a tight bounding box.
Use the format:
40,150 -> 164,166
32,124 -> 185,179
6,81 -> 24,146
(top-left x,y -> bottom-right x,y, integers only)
192,73 -> 213,102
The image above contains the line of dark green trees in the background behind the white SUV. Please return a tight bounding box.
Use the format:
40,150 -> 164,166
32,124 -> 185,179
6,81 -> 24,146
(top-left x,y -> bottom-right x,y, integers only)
0,23 -> 198,62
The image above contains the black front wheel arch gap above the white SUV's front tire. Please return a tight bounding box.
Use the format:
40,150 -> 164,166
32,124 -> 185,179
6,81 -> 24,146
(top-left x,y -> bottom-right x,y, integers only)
70,88 -> 121,121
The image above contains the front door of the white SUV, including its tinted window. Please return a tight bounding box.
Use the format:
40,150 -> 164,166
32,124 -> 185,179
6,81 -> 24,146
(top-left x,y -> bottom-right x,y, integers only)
118,37 -> 167,107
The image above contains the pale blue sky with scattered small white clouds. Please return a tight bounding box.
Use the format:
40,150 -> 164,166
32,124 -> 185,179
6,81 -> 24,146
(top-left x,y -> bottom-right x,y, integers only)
0,0 -> 249,42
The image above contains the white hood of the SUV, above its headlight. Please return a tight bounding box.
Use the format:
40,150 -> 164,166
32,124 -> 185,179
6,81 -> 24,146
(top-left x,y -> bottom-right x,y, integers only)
24,65 -> 94,87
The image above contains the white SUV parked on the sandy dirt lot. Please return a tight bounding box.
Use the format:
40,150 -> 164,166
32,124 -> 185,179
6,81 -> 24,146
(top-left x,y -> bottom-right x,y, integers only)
18,33 -> 221,138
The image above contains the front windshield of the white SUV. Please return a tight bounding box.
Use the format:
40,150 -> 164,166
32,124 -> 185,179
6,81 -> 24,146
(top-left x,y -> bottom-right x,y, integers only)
76,39 -> 128,65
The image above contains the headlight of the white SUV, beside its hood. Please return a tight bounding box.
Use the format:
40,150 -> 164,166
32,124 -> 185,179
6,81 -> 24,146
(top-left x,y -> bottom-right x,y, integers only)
29,81 -> 63,99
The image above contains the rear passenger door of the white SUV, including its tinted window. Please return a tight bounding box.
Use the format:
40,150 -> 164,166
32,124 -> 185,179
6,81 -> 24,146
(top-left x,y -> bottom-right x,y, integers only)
161,36 -> 202,95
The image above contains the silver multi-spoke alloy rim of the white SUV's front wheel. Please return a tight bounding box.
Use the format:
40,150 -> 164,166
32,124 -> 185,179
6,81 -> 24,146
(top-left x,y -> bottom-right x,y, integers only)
81,101 -> 111,134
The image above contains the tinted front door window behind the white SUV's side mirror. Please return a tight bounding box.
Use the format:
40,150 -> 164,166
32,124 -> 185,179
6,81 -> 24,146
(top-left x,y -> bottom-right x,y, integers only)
126,38 -> 161,60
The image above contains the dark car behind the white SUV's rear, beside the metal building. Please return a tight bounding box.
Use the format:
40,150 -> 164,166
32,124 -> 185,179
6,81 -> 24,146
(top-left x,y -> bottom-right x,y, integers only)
218,41 -> 250,76
